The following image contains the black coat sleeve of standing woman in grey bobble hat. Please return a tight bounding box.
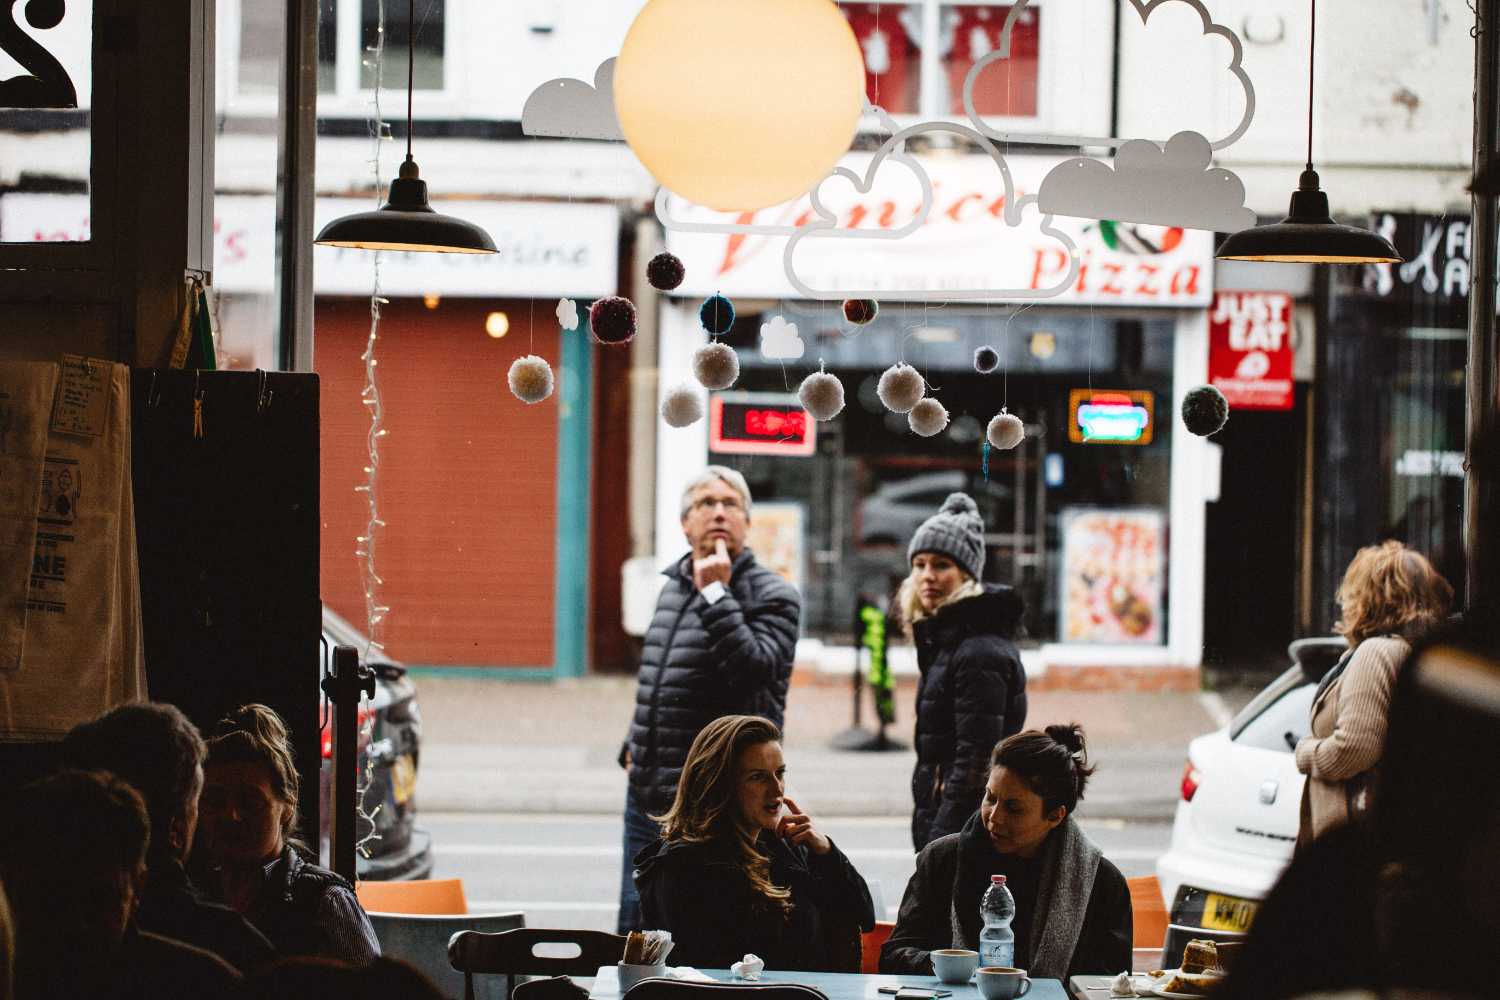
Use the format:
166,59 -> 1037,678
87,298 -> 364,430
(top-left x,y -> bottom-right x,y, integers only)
929,636 -> 1022,840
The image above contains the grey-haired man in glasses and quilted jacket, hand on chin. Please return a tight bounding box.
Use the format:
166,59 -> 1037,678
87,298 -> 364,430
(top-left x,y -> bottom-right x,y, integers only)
618,465 -> 803,934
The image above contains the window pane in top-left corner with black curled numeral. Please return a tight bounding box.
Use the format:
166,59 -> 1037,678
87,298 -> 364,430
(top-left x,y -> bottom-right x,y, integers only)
0,3 -> 93,243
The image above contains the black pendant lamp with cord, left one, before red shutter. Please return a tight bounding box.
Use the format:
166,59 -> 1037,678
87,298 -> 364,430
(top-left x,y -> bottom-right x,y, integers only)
314,0 -> 495,253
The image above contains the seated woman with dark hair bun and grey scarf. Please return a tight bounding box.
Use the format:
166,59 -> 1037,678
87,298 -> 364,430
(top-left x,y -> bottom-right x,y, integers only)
881,724 -> 1133,981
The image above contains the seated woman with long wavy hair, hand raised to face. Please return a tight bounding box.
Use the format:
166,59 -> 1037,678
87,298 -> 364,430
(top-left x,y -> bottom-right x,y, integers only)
635,715 -> 875,972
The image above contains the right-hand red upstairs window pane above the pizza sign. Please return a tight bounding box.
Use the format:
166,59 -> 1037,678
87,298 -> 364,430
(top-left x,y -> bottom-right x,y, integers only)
933,4 -> 1041,118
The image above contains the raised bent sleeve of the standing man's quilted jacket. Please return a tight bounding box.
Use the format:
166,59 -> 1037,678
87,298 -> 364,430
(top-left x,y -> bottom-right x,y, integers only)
702,579 -> 801,699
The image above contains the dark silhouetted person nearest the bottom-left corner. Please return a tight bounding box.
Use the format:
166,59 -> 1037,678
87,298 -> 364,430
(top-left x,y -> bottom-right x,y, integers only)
0,771 -> 242,1000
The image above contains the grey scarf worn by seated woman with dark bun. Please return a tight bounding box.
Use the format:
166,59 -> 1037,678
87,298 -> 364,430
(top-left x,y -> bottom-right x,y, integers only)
950,816 -> 1104,979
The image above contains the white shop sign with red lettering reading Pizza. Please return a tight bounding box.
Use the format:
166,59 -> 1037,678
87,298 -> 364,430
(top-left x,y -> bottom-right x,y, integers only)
668,153 -> 1214,307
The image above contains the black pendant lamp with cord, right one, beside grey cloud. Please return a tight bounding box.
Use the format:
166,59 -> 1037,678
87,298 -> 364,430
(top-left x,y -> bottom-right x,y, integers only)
1215,0 -> 1401,264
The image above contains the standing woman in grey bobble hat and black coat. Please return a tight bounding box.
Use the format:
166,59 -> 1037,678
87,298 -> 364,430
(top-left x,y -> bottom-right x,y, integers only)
897,493 -> 1026,850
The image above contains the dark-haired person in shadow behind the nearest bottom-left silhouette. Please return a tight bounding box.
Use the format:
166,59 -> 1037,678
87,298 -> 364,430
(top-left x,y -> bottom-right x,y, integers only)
63,703 -> 276,972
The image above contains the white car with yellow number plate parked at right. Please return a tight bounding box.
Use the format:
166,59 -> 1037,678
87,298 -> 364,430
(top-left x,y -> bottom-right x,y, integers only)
1157,637 -> 1349,969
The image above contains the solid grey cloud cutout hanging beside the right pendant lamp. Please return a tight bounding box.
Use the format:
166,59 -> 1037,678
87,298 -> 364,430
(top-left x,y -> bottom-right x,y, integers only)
1038,132 -> 1256,232
